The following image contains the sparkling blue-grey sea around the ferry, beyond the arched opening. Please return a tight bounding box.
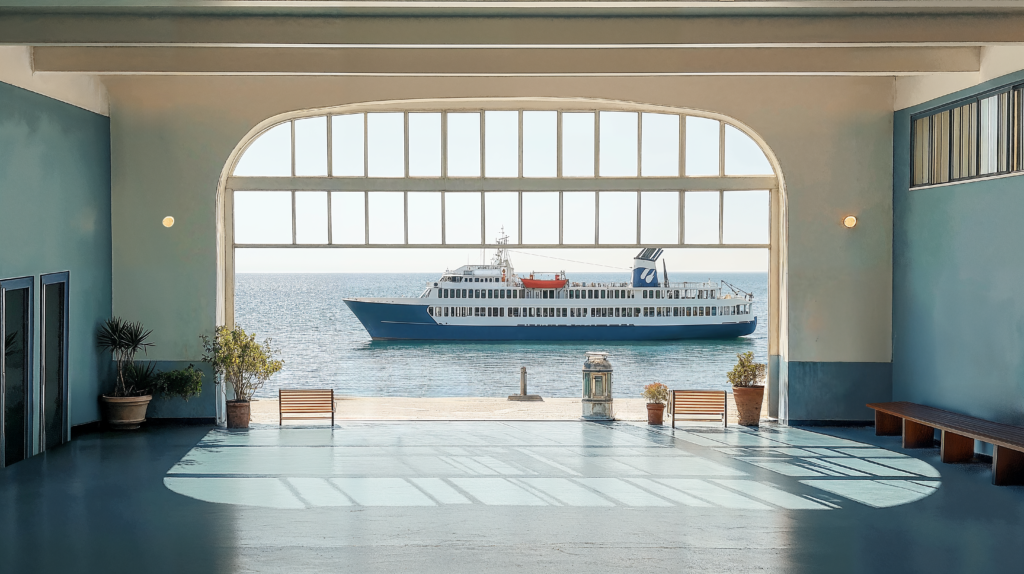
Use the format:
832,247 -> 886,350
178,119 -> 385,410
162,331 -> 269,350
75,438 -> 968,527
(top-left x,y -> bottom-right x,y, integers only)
234,272 -> 768,397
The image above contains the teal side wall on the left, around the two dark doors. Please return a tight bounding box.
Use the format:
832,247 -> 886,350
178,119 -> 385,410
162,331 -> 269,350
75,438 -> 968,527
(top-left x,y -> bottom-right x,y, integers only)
0,83 -> 111,425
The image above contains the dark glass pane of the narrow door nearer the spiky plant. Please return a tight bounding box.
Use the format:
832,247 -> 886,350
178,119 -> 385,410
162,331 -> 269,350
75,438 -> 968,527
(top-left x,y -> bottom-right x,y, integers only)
42,283 -> 67,448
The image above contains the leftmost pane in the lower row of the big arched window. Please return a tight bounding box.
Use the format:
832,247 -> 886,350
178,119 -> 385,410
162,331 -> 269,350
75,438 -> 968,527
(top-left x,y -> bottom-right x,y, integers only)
234,191 -> 292,244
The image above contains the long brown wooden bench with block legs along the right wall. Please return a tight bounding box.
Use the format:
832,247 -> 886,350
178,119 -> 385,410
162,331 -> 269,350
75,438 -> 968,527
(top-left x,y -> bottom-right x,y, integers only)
867,402 -> 1024,486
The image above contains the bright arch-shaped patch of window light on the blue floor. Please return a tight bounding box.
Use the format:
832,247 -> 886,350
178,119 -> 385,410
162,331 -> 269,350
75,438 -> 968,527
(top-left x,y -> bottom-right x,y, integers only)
164,422 -> 939,511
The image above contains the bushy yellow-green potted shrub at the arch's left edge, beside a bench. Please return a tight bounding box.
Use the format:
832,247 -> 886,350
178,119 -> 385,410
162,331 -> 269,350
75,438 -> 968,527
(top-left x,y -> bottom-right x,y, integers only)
201,326 -> 285,429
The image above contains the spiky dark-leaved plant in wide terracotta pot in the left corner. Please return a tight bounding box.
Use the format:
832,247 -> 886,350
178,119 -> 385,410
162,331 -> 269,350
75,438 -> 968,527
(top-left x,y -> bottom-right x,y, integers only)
96,317 -> 155,430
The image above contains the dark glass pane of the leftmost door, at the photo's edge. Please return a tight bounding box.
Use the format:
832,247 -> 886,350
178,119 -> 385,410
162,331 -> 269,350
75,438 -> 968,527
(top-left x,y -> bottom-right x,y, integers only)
3,289 -> 32,465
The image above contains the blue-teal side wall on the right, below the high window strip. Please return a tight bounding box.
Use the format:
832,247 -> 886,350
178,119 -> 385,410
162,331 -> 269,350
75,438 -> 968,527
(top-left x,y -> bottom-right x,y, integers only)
893,73 -> 1024,425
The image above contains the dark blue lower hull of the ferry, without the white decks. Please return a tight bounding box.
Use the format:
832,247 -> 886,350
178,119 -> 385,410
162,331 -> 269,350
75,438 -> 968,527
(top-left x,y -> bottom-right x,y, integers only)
345,300 -> 758,341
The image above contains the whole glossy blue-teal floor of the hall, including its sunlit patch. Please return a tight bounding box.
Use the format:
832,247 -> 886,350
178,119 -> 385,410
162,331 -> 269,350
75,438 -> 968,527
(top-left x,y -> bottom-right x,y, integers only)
0,422 -> 1024,572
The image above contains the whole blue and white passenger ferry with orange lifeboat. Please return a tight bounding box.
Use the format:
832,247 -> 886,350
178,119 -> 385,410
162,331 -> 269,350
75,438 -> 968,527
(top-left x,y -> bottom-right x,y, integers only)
344,237 -> 757,341
